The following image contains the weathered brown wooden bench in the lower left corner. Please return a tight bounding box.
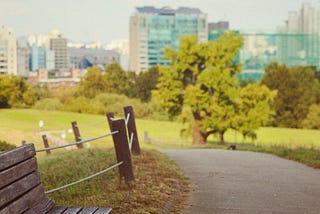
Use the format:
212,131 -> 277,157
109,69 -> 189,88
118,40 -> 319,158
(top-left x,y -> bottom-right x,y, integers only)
0,144 -> 112,214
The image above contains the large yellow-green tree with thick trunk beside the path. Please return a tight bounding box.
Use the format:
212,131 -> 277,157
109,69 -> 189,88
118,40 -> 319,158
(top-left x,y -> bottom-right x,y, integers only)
155,33 -> 242,144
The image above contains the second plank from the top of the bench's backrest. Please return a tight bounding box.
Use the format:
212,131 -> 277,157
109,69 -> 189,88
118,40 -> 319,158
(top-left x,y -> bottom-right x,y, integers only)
0,157 -> 37,189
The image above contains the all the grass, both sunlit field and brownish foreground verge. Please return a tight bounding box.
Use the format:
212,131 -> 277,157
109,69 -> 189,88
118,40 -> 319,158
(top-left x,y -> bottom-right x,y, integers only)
0,109 -> 320,213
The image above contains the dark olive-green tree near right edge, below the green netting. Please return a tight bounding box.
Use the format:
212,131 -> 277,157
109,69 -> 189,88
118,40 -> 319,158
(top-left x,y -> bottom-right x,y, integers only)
261,63 -> 320,128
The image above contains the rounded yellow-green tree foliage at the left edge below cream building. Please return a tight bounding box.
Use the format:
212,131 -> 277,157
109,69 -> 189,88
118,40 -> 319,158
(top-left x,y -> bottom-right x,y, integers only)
0,75 -> 35,108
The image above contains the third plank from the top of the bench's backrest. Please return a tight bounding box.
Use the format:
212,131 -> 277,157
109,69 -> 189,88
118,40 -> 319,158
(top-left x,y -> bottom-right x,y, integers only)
0,172 -> 41,207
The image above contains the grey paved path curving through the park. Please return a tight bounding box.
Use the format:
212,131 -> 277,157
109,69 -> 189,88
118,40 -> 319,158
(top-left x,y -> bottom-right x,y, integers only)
161,149 -> 320,214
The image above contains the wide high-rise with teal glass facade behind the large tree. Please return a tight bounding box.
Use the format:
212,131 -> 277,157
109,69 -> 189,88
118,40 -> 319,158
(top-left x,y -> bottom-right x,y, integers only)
129,7 -> 208,72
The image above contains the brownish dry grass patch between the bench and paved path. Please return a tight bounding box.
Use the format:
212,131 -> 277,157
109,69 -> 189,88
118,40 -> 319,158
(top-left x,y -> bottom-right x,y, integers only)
39,148 -> 189,213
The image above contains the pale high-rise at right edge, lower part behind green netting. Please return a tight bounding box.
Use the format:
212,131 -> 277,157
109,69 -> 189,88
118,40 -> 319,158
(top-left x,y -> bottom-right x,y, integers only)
277,3 -> 320,66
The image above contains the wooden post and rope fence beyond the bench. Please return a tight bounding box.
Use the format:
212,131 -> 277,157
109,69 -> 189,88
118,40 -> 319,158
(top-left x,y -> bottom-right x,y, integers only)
22,106 -> 140,194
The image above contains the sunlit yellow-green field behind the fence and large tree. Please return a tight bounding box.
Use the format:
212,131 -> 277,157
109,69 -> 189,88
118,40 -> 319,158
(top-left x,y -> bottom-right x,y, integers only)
0,109 -> 320,149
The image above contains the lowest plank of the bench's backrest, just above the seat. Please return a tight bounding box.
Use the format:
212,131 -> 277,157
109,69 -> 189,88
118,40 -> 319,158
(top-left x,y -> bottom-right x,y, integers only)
0,184 -> 44,214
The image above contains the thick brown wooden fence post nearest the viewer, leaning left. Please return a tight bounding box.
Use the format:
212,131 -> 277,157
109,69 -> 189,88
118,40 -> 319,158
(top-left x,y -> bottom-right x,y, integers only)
107,114 -> 134,183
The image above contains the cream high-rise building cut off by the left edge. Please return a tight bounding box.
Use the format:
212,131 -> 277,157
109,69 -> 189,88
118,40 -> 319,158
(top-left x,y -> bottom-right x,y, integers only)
0,25 -> 17,75
